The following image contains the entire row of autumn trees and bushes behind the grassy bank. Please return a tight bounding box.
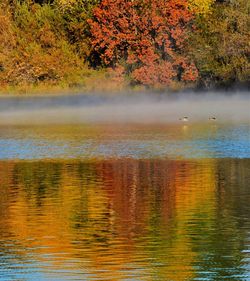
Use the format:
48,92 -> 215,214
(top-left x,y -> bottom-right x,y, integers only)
0,0 -> 250,89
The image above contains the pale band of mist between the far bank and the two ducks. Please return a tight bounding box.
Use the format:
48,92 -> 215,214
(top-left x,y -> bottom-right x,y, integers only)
0,92 -> 250,125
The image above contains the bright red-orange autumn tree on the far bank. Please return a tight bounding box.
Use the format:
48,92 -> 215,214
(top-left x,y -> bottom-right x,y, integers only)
89,0 -> 197,85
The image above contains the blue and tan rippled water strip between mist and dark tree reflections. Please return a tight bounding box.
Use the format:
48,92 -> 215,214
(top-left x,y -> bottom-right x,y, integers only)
0,122 -> 250,160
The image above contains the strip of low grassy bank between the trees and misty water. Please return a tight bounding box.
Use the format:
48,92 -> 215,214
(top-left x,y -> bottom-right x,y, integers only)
0,77 -> 250,98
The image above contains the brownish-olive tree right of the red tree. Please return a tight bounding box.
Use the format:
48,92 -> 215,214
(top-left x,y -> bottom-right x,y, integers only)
188,0 -> 250,88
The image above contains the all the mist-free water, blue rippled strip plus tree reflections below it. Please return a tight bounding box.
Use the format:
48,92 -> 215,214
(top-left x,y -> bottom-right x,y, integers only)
0,122 -> 250,281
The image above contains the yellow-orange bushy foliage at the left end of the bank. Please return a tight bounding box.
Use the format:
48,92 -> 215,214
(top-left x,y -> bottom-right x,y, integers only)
0,0 -> 83,85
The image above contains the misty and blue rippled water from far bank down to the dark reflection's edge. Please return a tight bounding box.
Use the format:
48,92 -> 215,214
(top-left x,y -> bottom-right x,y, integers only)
0,89 -> 250,160
